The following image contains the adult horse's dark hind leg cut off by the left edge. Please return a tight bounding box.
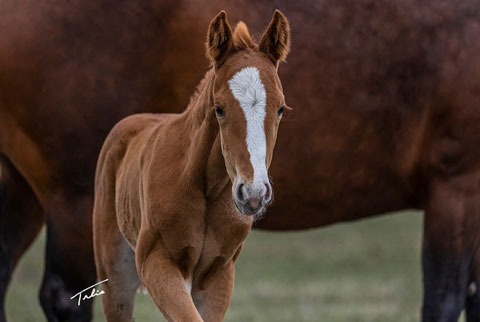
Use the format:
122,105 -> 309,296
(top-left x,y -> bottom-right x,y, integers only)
0,154 -> 44,322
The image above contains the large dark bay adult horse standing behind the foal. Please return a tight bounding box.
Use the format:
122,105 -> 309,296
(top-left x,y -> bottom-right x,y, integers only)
0,0 -> 480,321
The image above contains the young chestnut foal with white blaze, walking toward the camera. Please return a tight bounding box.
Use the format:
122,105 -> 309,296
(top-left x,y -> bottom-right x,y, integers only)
93,11 -> 290,322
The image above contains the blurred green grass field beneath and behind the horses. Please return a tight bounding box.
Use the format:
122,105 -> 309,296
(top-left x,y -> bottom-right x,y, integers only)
7,212 -> 423,322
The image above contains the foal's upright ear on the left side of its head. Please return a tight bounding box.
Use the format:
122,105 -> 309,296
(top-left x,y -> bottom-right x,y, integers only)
206,10 -> 234,68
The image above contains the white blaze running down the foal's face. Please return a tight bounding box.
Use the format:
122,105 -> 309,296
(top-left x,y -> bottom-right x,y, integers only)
228,67 -> 268,191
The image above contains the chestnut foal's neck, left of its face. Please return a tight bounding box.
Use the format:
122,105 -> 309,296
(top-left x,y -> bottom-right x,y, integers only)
182,69 -> 229,199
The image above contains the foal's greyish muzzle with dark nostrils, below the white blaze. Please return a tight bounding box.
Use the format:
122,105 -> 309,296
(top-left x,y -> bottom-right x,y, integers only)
232,180 -> 273,216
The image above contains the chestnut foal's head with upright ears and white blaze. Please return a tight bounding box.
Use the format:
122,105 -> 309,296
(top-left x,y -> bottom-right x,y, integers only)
206,10 -> 290,215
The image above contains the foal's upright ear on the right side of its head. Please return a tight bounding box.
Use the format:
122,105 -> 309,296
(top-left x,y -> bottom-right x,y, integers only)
258,10 -> 290,65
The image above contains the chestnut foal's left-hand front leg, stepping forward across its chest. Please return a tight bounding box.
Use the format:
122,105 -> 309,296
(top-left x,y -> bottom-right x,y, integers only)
136,232 -> 203,322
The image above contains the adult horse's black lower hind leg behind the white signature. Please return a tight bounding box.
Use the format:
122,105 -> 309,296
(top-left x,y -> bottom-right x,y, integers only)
40,193 -> 96,322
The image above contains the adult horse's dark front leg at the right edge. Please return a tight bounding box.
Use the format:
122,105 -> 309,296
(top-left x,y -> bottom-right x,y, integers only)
422,175 -> 480,322
